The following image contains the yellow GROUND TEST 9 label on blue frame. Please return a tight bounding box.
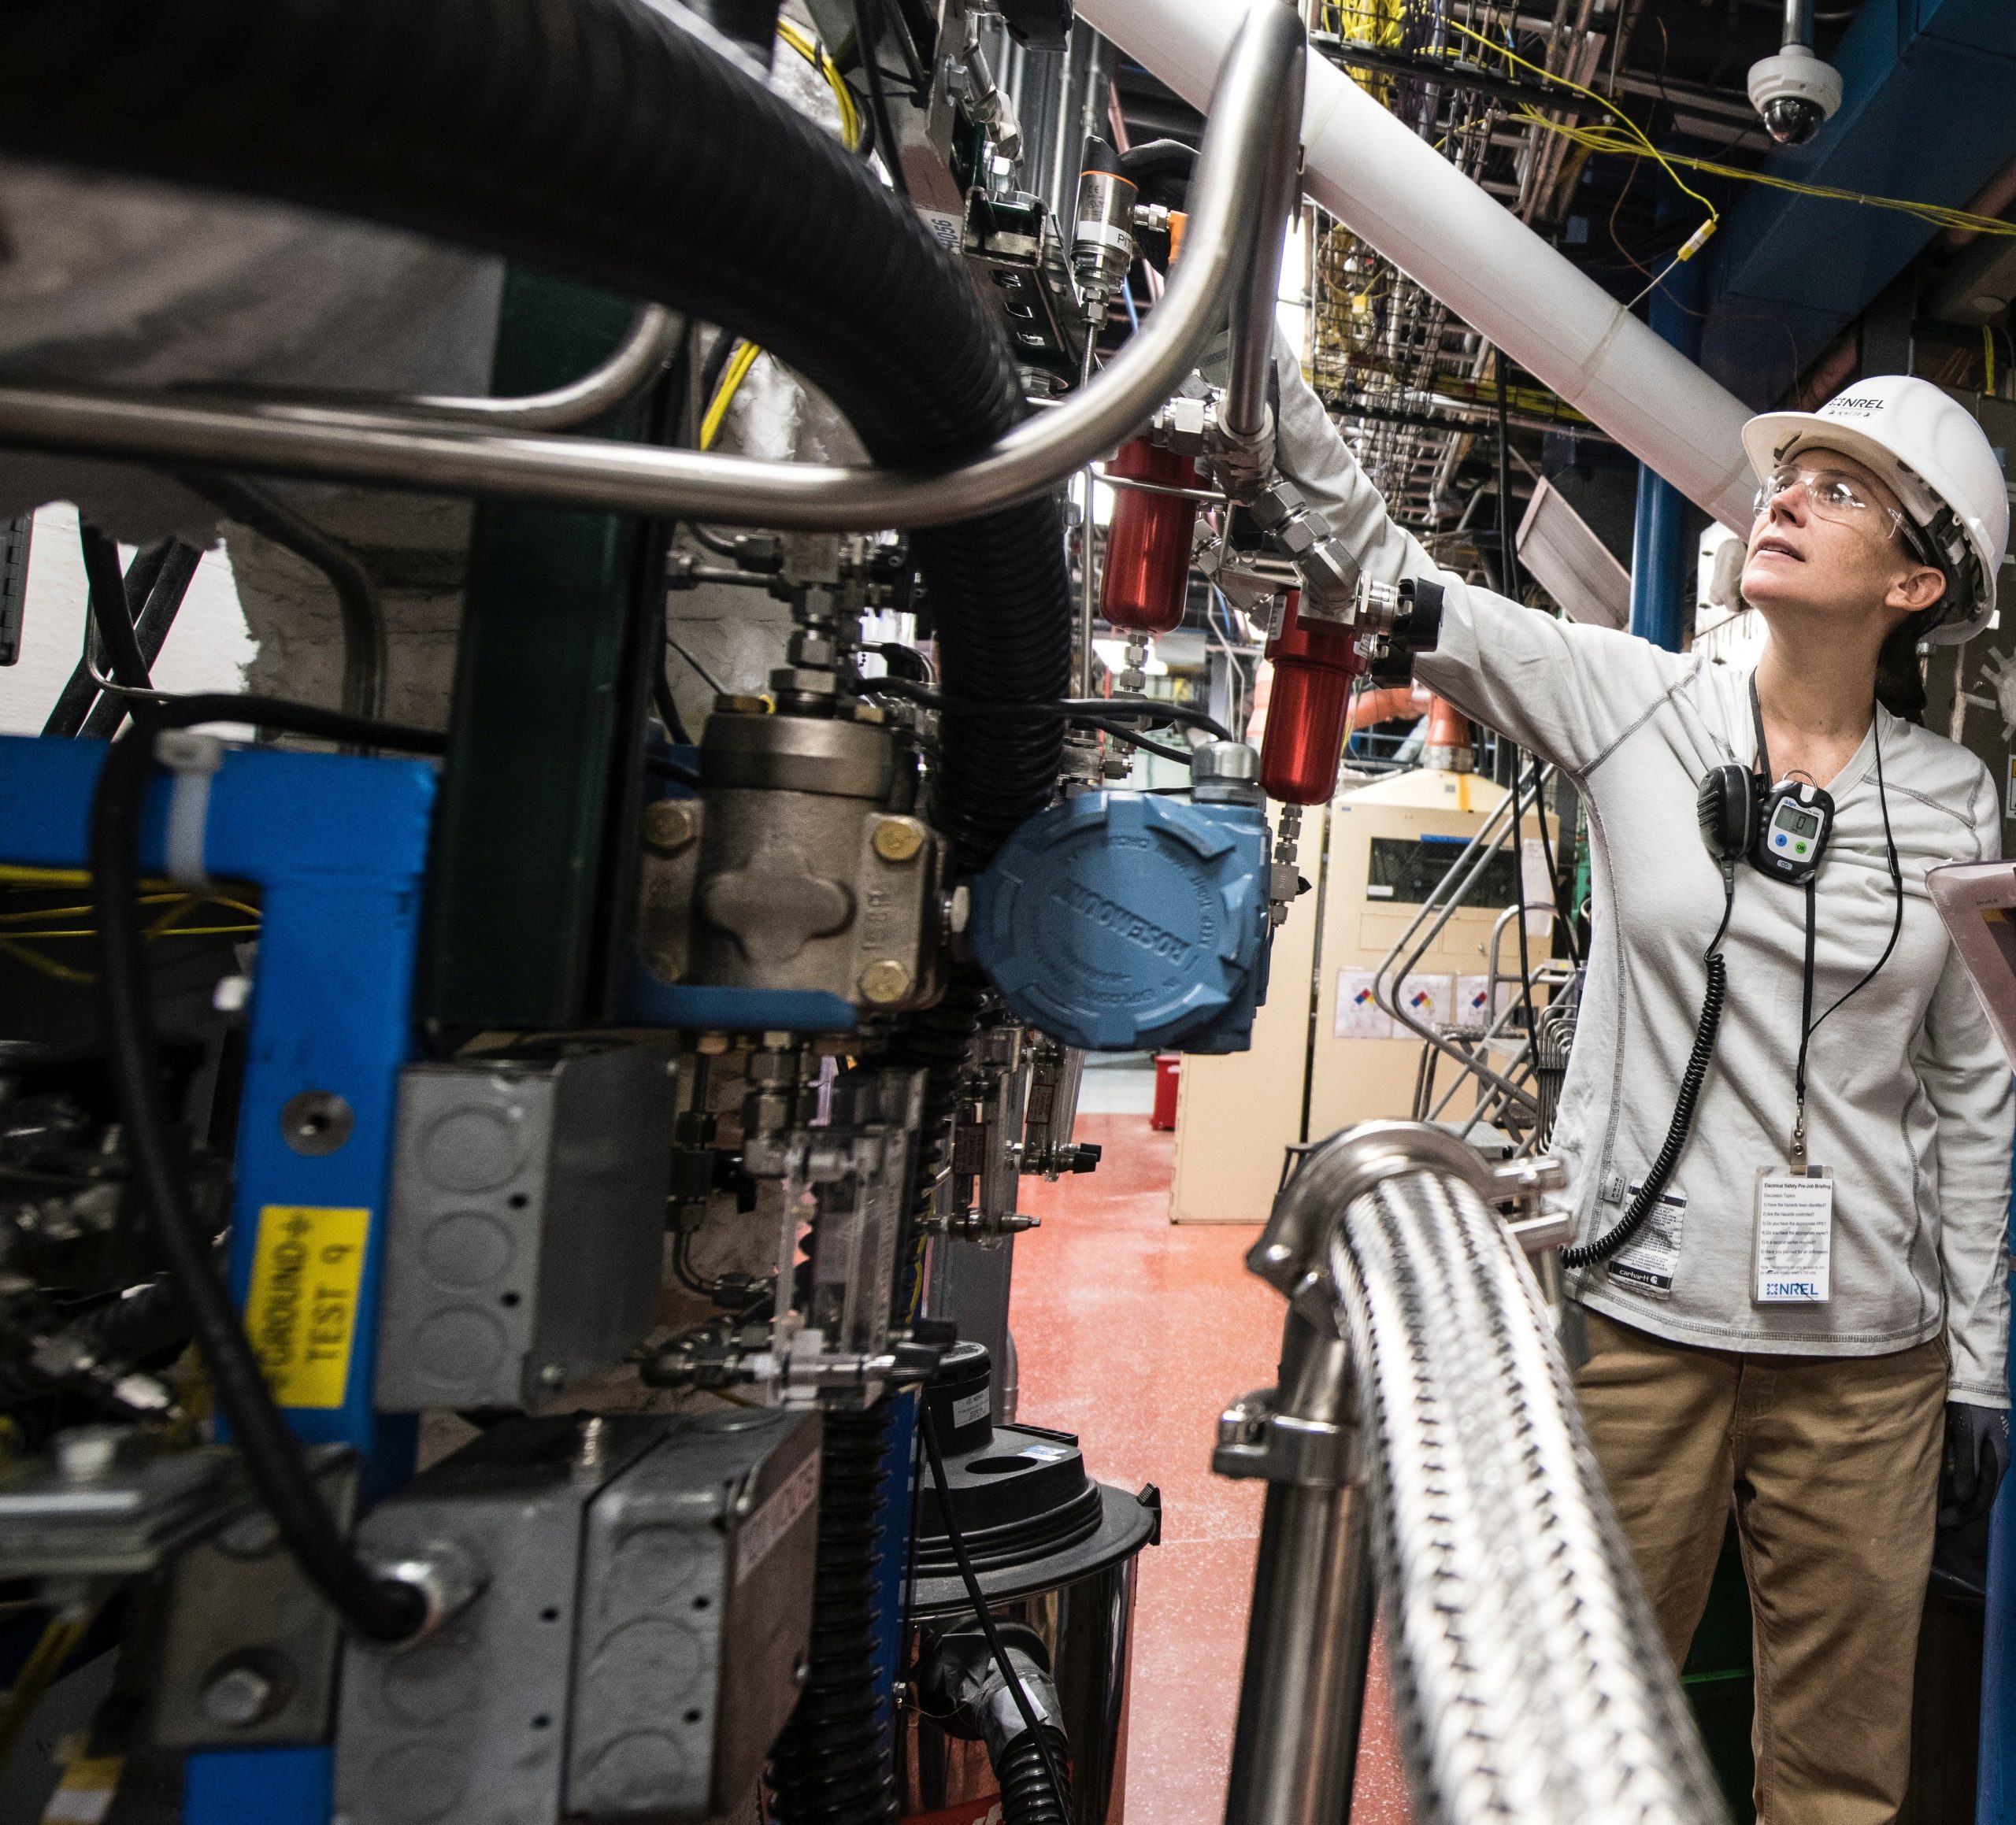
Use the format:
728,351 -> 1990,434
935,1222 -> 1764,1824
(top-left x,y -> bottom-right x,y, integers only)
246,1204 -> 371,1408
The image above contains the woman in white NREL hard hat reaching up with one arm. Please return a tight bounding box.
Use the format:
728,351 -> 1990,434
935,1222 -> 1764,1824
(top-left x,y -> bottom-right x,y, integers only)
1278,361 -> 2012,1825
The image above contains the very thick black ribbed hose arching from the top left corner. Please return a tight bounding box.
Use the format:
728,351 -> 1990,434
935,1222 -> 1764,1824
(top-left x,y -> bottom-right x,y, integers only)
0,0 -> 1070,867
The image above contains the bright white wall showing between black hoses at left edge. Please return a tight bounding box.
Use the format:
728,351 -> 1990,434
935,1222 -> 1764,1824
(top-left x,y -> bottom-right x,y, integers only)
0,502 -> 258,734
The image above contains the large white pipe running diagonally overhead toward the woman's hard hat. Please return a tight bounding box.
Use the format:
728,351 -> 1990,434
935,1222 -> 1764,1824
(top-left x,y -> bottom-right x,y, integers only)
1079,0 -> 1756,532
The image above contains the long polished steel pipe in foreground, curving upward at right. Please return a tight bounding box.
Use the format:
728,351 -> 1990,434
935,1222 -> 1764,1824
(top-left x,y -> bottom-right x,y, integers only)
0,4 -> 1304,532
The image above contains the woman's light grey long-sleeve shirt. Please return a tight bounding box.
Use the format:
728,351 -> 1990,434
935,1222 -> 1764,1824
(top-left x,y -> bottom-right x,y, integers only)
1276,339 -> 2016,1405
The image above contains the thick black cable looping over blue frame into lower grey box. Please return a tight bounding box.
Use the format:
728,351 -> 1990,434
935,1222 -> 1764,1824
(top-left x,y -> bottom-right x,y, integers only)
91,694 -> 447,1642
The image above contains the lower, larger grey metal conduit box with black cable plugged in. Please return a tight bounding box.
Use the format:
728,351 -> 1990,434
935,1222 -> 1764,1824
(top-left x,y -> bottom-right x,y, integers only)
337,1408 -> 821,1825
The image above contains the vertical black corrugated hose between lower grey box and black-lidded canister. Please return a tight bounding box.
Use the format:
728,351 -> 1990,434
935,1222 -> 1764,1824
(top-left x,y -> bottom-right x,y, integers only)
770,1401 -> 897,1825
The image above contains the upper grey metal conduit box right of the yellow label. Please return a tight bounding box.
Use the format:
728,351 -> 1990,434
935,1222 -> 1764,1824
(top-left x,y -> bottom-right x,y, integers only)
377,1045 -> 673,1412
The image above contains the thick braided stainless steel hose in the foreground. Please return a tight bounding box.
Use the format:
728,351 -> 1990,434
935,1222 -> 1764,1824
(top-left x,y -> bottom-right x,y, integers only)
1329,1170 -> 1728,1825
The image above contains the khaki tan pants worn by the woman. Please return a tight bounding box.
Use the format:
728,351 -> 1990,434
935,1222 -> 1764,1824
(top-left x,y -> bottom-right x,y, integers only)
1577,1312 -> 1947,1825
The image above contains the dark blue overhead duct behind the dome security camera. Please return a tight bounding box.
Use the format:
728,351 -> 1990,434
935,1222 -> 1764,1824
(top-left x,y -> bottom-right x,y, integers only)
1702,0 -> 2016,407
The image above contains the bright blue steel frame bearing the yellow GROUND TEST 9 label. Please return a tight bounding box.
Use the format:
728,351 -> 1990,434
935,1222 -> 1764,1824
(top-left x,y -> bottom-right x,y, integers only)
0,736 -> 435,1825
